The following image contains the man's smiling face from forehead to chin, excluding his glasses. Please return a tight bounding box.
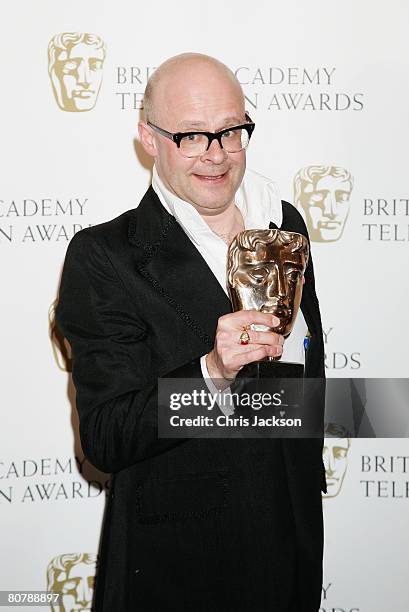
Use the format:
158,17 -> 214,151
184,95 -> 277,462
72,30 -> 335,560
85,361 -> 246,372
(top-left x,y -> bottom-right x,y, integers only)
153,64 -> 246,215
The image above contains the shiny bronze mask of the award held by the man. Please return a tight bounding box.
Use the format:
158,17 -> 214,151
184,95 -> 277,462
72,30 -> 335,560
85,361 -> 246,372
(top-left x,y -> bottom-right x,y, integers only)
227,230 -> 309,336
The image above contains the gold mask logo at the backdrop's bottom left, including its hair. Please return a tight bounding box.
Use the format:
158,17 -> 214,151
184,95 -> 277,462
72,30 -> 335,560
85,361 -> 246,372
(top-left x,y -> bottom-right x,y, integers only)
47,553 -> 97,612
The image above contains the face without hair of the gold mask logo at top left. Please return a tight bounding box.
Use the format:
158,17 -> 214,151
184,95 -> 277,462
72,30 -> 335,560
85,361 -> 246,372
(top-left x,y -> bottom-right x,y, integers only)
53,43 -> 104,111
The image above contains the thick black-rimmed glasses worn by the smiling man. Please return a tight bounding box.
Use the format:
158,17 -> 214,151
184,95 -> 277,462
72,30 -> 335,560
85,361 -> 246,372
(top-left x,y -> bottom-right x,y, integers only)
147,113 -> 255,157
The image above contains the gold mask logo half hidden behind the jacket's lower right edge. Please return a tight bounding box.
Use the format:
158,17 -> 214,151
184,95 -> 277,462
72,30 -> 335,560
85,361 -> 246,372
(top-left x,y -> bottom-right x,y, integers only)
322,423 -> 351,499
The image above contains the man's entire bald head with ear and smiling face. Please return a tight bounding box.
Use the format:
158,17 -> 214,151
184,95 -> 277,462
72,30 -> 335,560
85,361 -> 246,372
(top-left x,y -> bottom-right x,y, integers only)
138,53 -> 248,216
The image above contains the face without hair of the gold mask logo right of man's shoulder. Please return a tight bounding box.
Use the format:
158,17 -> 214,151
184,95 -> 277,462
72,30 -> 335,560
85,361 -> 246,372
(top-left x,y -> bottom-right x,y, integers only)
300,176 -> 351,242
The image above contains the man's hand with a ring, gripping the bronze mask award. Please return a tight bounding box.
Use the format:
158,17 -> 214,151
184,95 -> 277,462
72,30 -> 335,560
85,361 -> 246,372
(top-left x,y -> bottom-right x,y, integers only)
206,310 -> 284,388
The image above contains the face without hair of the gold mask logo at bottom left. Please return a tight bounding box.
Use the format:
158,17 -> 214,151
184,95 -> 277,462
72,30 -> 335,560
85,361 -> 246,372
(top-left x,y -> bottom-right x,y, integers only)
53,563 -> 95,612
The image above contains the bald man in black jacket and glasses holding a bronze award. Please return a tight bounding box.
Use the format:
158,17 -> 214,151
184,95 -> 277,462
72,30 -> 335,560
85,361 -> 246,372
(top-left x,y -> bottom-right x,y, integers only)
56,53 -> 325,612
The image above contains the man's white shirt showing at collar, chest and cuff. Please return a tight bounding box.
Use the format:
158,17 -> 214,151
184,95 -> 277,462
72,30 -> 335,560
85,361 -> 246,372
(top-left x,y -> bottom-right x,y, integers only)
152,166 -> 307,414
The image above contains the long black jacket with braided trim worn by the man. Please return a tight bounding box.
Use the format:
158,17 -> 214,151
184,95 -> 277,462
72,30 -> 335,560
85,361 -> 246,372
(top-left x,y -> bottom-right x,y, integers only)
56,187 -> 325,612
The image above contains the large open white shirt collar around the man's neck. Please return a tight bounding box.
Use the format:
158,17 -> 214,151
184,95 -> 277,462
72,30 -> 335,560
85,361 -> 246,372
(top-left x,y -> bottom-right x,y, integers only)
152,166 -> 283,245
